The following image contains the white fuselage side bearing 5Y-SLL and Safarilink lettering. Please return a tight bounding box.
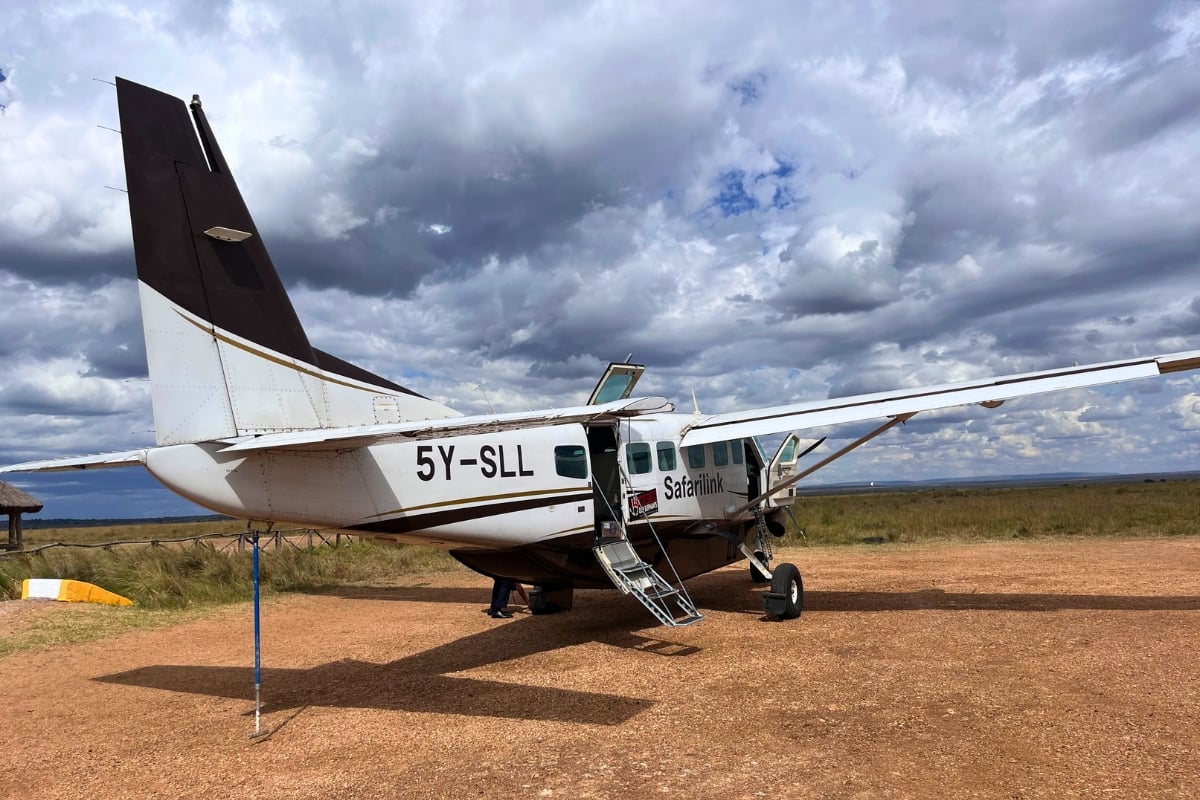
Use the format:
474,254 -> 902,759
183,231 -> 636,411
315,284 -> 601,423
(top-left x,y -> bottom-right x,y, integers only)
146,414 -> 748,548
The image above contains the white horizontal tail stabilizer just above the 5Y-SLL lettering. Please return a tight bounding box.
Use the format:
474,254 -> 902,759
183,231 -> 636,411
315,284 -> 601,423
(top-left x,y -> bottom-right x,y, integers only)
221,397 -> 674,453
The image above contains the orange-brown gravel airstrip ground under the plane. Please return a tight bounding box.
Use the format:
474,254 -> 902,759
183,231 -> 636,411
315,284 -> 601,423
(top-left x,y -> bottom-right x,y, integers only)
0,539 -> 1200,800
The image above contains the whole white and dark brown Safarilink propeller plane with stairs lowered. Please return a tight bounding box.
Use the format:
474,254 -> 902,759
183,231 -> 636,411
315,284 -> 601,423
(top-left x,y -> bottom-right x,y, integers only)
0,78 -> 1200,626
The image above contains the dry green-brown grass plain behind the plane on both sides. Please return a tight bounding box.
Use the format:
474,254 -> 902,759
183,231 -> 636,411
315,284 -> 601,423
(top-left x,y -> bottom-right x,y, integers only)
0,481 -> 1200,609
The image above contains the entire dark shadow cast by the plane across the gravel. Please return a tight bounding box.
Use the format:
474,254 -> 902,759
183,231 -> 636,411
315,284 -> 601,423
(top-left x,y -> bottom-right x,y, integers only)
95,572 -> 1200,726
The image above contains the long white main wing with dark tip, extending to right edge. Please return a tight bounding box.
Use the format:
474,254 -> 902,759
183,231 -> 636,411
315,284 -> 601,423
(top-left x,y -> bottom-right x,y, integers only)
682,350 -> 1200,445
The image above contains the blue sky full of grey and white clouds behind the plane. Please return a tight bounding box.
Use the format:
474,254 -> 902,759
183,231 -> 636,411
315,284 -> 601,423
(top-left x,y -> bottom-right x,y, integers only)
0,0 -> 1200,517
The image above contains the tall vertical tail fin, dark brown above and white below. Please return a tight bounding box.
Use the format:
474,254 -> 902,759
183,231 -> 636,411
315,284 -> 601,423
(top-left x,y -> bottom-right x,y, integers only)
116,78 -> 458,445
